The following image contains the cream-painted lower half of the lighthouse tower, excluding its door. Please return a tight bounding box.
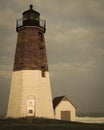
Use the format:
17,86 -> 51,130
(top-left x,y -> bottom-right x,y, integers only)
7,70 -> 54,118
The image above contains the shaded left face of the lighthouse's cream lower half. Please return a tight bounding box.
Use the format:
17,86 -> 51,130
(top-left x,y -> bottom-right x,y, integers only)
7,72 -> 22,117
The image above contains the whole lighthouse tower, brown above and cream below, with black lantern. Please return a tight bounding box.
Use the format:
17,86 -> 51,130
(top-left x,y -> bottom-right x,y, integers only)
7,5 -> 54,118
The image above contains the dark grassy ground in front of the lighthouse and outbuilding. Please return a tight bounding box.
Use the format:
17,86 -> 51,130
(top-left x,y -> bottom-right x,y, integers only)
0,118 -> 104,130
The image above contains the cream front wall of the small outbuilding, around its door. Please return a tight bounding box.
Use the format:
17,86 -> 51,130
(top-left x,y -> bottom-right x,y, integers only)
55,101 -> 76,121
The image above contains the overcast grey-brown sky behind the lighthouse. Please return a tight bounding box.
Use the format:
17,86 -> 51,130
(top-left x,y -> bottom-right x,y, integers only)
0,0 -> 104,116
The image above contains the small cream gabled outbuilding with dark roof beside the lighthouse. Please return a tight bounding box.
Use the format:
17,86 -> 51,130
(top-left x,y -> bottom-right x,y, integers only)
53,96 -> 76,121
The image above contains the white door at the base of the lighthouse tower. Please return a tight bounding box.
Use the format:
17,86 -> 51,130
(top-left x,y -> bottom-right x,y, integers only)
27,99 -> 35,116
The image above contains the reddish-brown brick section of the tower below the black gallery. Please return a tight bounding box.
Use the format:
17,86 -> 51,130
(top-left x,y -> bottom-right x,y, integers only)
13,26 -> 48,71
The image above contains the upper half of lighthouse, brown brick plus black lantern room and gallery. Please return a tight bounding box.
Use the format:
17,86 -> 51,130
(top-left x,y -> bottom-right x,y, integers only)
13,5 -> 48,71
